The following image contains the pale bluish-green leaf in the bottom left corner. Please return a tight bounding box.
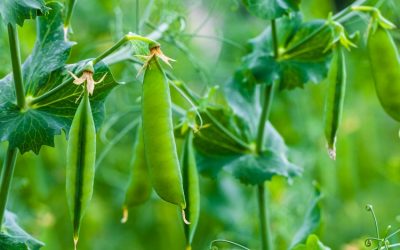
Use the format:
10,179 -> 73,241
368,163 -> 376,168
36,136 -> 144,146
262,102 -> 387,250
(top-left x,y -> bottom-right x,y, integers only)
0,211 -> 44,250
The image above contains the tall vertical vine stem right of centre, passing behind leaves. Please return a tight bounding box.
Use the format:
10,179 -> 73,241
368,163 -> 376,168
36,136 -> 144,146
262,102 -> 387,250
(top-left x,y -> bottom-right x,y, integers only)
256,19 -> 279,250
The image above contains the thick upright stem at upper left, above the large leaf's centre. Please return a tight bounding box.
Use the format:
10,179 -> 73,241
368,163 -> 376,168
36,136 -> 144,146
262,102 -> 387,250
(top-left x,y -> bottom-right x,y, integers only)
8,23 -> 25,109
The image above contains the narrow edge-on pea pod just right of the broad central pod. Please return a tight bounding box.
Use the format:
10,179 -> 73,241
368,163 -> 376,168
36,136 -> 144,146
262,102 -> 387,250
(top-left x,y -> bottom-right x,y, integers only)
181,131 -> 200,250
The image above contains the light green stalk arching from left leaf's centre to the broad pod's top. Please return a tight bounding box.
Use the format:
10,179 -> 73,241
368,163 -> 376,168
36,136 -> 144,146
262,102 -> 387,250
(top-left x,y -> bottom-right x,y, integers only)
29,33 -> 160,106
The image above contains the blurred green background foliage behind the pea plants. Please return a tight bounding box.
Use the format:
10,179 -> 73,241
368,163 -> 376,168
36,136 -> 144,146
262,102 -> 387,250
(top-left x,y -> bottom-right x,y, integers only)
0,0 -> 400,250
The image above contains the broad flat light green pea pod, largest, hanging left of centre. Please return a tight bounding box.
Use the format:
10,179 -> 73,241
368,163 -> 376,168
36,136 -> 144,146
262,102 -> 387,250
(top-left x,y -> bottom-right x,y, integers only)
142,57 -> 186,209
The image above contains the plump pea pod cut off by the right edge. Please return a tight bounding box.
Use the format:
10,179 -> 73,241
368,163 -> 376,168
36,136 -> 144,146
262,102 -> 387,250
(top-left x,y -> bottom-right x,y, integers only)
368,27 -> 400,121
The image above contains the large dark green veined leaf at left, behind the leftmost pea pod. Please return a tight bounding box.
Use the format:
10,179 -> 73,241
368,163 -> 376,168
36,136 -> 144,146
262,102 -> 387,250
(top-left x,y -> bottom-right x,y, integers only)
0,3 -> 117,154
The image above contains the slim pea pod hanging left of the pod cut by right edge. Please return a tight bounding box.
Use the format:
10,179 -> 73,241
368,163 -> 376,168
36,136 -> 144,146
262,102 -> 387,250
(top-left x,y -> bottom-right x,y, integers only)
325,46 -> 346,159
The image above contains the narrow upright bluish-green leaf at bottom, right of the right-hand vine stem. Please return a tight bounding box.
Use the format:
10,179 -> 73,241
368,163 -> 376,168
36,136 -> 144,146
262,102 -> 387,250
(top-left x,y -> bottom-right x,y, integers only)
290,185 -> 322,248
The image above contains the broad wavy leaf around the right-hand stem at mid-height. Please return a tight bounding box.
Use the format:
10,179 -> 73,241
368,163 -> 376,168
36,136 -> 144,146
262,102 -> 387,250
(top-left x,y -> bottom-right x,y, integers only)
194,106 -> 300,185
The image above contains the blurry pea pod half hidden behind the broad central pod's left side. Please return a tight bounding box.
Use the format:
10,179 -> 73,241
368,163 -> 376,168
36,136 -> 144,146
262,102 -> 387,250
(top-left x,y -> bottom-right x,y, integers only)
122,125 -> 152,223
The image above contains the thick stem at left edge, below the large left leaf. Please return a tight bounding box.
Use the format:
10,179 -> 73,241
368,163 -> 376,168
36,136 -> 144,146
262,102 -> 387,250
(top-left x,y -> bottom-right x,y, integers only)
0,147 -> 17,224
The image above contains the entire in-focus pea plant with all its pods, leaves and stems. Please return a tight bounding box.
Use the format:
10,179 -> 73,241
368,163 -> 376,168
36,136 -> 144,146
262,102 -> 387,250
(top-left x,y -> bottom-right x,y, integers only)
0,0 -> 400,250
